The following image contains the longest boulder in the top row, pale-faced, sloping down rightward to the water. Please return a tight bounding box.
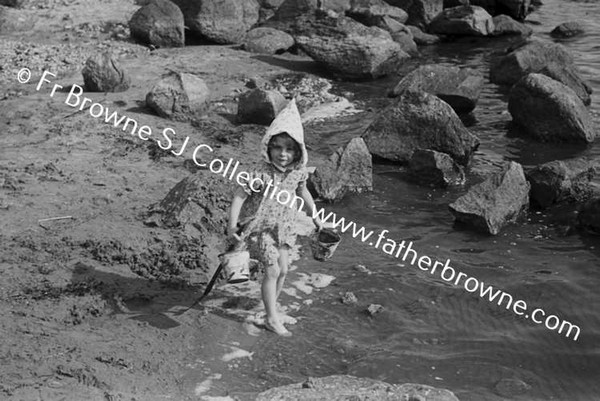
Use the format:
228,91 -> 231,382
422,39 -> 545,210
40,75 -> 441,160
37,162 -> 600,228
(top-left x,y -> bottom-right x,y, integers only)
294,15 -> 410,80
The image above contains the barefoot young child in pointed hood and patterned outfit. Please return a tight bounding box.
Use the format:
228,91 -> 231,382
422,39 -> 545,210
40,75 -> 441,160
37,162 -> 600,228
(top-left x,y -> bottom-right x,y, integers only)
228,100 -> 322,336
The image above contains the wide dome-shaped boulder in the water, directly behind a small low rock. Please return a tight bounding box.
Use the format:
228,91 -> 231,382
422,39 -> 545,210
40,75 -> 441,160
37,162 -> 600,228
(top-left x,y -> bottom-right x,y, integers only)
363,91 -> 479,165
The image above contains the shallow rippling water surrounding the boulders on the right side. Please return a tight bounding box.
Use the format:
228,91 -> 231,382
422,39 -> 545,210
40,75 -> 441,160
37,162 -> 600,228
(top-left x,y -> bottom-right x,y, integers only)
202,0 -> 600,401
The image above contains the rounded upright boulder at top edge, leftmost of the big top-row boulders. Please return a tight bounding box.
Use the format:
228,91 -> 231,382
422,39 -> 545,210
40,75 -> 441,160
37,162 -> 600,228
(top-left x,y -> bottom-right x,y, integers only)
129,0 -> 185,47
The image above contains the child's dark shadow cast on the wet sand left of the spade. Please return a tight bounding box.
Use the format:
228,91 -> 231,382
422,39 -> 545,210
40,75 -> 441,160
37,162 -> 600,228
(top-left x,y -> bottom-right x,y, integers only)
70,262 -> 203,329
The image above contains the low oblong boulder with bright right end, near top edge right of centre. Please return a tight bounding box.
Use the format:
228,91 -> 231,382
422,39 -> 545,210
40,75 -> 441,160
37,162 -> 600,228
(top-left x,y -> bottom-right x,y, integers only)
428,6 -> 494,36
